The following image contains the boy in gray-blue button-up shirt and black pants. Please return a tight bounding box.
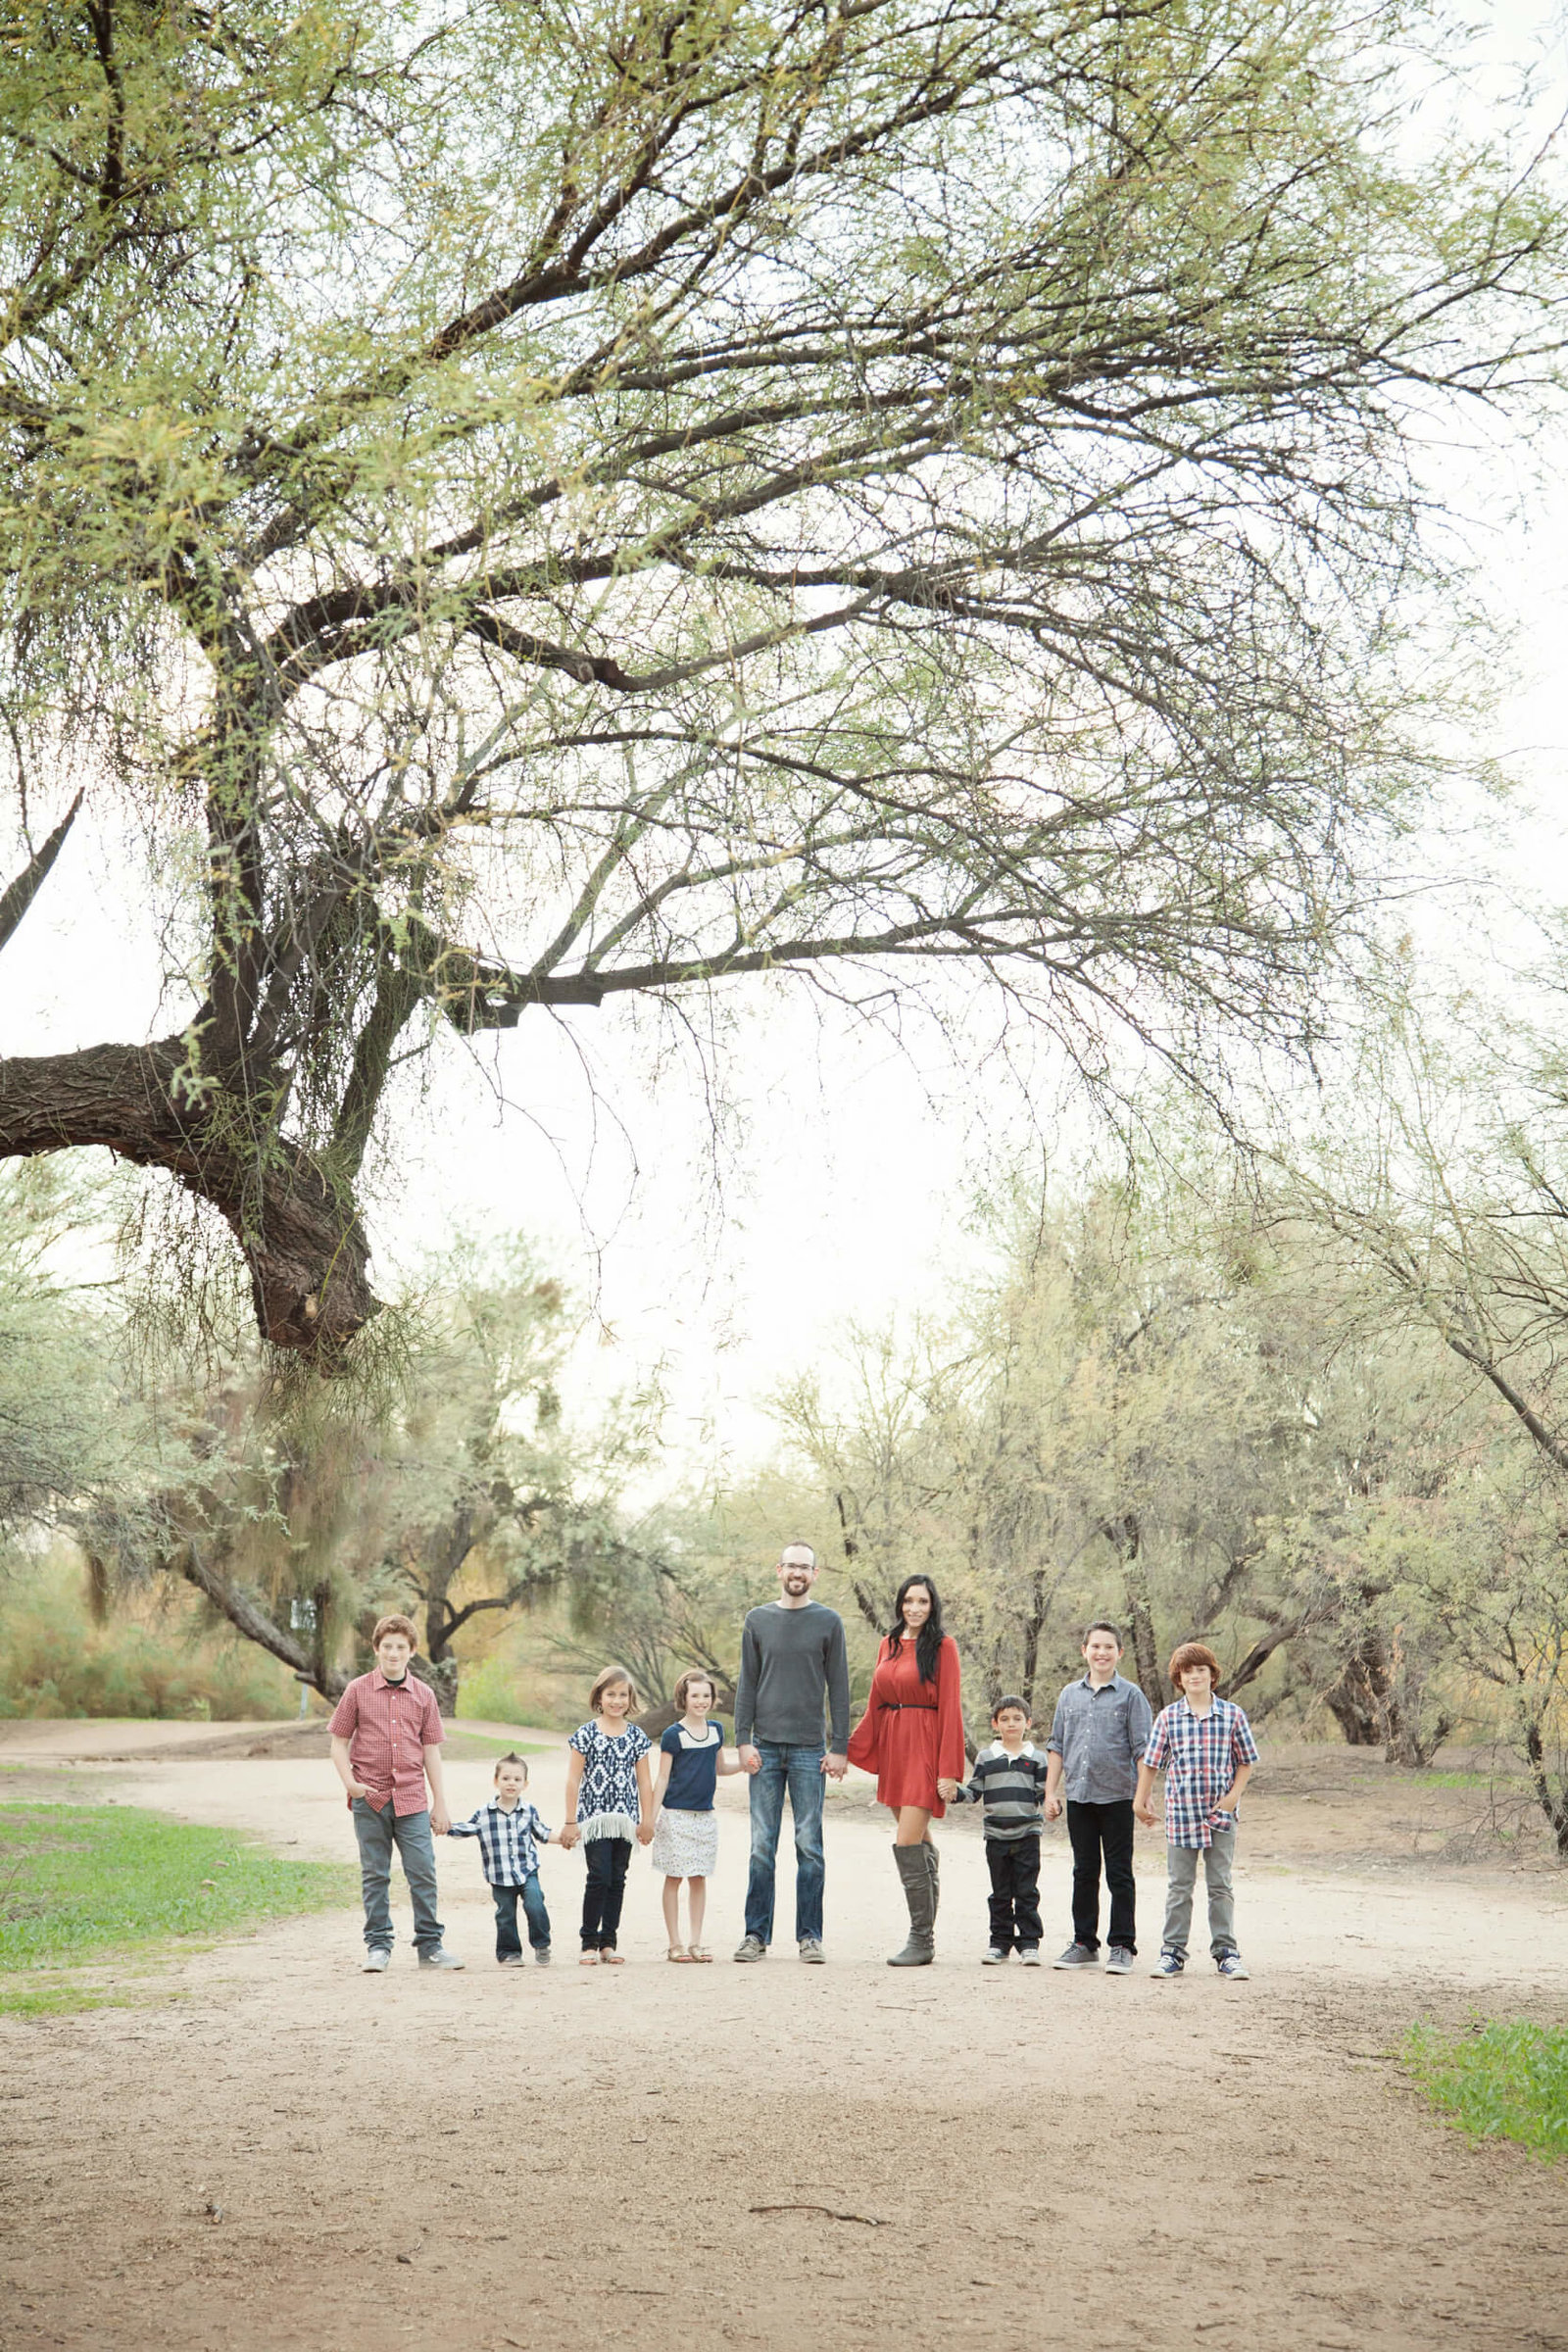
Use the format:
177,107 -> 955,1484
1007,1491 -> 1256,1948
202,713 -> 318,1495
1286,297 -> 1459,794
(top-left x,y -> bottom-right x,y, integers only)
1046,1623 -> 1154,1976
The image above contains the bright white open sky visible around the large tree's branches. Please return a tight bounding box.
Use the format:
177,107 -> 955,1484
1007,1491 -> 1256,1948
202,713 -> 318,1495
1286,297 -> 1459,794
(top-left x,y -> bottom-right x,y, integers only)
5,0 -> 1568,1475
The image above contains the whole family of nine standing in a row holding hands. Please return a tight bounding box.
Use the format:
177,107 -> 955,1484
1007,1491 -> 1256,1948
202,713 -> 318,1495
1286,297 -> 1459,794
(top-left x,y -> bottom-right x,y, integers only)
329,1543 -> 1257,1978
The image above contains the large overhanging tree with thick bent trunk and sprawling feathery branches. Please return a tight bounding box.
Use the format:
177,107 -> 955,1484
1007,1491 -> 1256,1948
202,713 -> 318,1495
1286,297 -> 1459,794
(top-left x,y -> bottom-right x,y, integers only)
0,0 -> 1556,1364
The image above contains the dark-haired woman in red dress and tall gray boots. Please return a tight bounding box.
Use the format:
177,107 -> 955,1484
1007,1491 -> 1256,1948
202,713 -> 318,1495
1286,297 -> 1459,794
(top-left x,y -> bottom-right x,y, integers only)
849,1576 -> 964,1969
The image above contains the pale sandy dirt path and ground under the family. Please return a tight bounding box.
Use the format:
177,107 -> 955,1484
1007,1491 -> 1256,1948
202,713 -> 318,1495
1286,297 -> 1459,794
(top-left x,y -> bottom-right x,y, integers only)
0,1727 -> 1568,2352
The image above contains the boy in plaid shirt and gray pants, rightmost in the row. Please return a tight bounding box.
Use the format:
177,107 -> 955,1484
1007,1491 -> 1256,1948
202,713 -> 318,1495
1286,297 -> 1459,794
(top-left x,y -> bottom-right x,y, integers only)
1133,1642 -> 1257,1978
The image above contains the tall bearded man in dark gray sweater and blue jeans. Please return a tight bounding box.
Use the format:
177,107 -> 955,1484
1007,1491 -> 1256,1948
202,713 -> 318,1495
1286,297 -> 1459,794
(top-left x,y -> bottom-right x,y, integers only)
736,1543 -> 849,1962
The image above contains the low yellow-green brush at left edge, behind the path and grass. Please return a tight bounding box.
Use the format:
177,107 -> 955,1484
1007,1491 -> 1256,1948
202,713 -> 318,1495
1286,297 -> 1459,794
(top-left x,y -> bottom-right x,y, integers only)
0,1557 -> 296,1722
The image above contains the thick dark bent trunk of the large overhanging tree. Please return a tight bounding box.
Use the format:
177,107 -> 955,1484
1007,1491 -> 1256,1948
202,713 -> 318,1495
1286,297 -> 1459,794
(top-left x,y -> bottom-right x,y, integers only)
0,1037 -> 378,1369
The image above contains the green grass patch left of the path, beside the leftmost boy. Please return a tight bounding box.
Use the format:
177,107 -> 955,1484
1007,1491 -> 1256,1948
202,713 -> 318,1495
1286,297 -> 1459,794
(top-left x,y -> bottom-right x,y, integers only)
0,1804 -> 358,2016
